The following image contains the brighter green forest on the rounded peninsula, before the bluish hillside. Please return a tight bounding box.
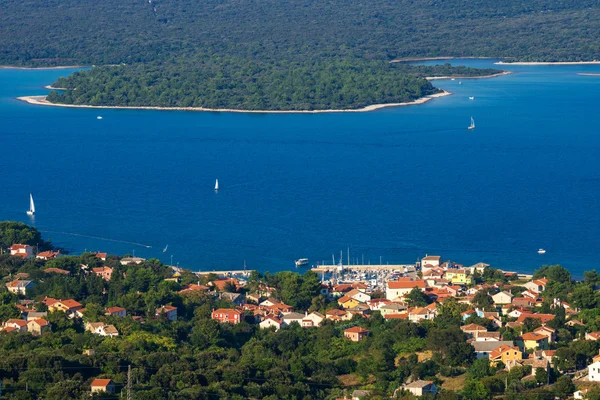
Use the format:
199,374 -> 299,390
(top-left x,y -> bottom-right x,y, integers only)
48,57 -> 498,110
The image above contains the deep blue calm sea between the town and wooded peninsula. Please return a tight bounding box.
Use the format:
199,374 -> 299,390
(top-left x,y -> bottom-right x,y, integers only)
0,60 -> 600,275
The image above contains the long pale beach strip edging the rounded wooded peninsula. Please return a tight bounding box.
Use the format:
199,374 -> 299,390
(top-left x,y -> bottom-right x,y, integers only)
17,90 -> 452,114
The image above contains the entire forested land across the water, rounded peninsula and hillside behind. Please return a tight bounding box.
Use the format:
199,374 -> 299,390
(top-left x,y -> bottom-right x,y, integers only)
0,0 -> 600,110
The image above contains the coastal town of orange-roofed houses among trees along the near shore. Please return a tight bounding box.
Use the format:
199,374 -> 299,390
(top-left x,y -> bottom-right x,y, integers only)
0,223 -> 600,400
